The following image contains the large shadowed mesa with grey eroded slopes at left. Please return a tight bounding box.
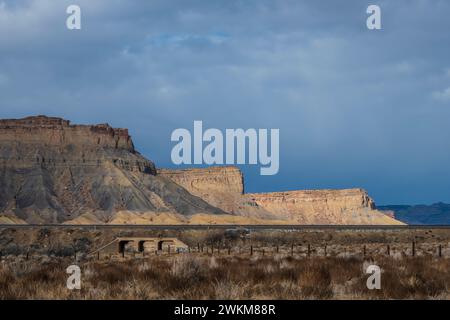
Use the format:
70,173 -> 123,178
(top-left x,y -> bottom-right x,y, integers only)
0,116 -> 224,223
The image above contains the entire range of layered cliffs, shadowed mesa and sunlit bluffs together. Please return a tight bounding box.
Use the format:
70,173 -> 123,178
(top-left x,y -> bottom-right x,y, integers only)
0,116 -> 399,224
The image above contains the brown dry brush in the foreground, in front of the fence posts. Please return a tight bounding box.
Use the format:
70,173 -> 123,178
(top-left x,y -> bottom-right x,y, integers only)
0,254 -> 450,299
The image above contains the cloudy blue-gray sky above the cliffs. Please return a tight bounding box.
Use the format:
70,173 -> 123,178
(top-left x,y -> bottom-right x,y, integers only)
0,0 -> 450,204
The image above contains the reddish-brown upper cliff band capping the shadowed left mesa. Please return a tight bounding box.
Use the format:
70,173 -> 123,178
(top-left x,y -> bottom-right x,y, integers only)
0,116 -> 156,175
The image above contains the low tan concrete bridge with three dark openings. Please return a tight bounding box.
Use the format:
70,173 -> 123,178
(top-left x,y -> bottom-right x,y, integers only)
92,237 -> 188,254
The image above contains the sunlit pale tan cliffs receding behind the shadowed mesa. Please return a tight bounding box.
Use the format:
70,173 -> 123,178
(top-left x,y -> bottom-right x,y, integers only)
158,167 -> 399,224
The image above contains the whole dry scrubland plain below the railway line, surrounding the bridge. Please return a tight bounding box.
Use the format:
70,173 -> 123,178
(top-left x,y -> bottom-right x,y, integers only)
0,228 -> 450,299
